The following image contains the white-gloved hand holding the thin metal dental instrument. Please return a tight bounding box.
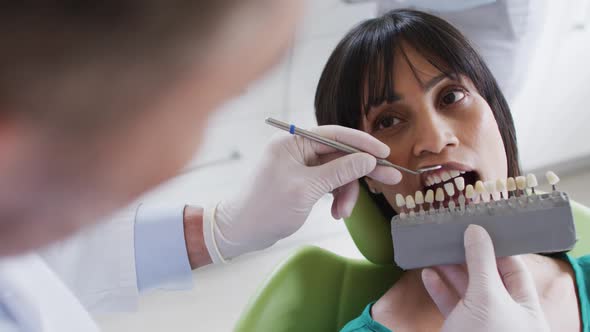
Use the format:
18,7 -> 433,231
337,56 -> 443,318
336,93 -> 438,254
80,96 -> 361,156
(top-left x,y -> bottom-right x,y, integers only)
205,126 -> 401,262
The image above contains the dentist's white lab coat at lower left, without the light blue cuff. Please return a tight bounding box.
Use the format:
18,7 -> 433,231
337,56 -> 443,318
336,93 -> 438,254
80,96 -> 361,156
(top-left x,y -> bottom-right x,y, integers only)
0,209 -> 138,332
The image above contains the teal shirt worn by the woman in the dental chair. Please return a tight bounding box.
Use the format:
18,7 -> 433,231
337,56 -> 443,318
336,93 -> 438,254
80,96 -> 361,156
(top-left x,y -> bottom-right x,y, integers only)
340,255 -> 590,332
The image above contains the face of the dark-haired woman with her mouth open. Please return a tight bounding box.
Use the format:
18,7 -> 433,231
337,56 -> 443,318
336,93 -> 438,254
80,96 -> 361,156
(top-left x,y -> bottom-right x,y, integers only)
361,45 -> 507,212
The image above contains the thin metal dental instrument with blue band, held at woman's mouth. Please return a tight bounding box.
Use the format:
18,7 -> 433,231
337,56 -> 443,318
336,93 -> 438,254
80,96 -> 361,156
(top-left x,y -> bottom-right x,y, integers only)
264,118 -> 442,175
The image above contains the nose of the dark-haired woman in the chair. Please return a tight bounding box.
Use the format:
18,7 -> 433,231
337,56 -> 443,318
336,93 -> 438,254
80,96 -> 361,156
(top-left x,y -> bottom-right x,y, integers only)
413,113 -> 459,157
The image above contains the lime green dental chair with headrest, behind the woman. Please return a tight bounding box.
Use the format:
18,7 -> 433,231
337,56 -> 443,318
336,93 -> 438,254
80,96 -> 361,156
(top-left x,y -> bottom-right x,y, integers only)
235,188 -> 590,332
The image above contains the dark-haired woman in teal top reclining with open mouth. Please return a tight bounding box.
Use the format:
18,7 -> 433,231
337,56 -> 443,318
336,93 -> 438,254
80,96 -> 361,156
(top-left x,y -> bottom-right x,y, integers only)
315,10 -> 590,332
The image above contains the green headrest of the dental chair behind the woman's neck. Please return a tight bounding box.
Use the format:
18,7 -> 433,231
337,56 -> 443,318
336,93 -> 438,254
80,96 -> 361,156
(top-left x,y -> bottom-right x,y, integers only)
344,186 -> 590,265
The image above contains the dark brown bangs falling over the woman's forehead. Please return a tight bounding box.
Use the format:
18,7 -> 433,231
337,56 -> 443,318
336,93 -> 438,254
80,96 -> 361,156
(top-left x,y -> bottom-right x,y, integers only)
350,16 -> 481,114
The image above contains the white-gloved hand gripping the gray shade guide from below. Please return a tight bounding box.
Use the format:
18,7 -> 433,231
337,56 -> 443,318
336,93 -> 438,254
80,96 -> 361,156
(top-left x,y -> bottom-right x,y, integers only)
422,225 -> 549,332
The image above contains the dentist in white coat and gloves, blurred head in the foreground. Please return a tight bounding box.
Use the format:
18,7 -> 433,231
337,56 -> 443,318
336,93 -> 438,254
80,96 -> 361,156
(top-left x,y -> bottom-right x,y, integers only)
0,0 -> 552,332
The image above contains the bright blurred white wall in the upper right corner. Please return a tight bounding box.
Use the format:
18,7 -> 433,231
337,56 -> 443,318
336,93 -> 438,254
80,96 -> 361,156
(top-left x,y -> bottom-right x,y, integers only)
512,0 -> 590,169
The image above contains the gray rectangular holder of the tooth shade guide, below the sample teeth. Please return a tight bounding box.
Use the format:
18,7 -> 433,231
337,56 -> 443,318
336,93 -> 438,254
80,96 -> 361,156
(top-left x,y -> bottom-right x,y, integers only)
391,191 -> 576,269
